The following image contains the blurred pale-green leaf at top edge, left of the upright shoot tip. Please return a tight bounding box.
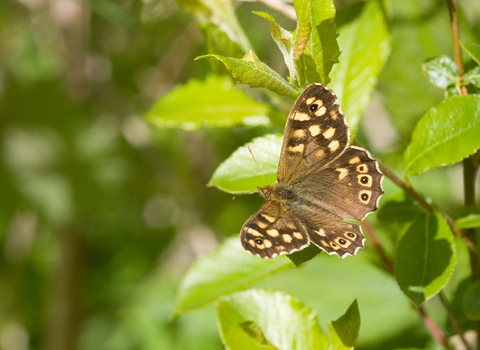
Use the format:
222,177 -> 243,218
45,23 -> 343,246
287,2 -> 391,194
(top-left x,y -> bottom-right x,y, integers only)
177,0 -> 251,56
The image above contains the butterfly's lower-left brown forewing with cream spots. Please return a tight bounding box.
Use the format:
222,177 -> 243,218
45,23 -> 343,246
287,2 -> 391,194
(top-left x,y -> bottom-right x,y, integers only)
240,200 -> 309,259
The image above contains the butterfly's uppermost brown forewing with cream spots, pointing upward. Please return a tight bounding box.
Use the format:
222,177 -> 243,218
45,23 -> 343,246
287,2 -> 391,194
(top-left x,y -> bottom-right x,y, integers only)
278,84 -> 349,183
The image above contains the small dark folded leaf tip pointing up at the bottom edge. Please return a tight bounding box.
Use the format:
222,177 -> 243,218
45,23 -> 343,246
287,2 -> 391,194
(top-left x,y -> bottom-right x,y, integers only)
328,299 -> 360,350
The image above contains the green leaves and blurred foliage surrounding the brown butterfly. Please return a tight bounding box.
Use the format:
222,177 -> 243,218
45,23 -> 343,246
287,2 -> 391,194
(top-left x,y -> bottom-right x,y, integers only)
0,0 -> 480,350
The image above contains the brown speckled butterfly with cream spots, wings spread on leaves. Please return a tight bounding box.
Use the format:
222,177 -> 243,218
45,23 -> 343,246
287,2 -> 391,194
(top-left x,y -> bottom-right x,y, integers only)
241,84 -> 383,258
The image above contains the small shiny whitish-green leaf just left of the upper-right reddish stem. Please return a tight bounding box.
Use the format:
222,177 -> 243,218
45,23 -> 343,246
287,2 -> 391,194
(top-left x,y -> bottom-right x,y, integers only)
422,56 -> 458,89
